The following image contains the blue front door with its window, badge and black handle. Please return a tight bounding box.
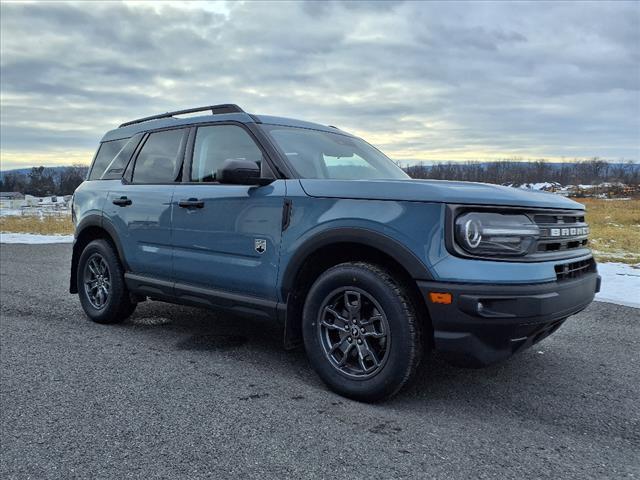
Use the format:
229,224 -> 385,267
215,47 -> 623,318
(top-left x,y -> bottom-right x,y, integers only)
172,124 -> 285,300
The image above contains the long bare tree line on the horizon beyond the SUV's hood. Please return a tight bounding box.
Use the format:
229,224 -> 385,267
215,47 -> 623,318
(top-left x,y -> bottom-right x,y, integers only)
405,158 -> 640,185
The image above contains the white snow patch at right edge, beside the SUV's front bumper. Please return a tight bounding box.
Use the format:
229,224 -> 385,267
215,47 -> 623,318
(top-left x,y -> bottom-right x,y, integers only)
596,263 -> 640,308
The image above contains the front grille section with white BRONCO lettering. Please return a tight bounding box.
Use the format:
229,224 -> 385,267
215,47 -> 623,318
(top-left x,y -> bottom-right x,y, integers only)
533,213 -> 589,253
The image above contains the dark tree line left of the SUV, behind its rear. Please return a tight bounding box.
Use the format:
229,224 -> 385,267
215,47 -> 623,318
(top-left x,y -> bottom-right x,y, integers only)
0,165 -> 89,197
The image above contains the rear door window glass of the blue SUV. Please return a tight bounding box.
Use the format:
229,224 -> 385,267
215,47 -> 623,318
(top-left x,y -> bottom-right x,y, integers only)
133,129 -> 186,183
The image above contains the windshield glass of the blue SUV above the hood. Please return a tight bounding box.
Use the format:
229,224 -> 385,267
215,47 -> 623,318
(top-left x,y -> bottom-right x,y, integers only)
264,125 -> 409,180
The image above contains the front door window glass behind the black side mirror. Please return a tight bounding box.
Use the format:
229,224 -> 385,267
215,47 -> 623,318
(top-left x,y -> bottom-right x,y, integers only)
191,125 -> 262,182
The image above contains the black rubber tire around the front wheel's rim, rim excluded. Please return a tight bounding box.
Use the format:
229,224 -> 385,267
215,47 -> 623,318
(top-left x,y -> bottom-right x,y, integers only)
302,265 -> 414,400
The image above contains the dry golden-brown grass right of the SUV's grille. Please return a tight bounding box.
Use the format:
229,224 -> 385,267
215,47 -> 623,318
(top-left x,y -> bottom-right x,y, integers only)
577,198 -> 640,264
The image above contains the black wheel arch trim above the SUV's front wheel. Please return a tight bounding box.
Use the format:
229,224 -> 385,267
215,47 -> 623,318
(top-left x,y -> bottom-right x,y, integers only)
281,227 -> 433,299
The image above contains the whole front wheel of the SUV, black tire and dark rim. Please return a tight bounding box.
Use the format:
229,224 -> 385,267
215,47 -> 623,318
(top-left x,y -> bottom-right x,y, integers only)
302,262 -> 423,402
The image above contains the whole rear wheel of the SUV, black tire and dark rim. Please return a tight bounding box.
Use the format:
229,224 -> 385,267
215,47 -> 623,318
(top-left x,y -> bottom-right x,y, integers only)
77,239 -> 136,323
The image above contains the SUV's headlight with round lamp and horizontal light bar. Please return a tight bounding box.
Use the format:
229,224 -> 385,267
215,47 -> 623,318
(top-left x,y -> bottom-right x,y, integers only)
455,212 -> 540,257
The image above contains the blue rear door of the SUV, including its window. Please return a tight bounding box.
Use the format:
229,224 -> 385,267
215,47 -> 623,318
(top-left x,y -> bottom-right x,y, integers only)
104,128 -> 188,281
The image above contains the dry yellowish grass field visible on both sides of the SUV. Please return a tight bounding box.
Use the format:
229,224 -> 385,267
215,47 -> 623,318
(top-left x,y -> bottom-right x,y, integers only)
0,198 -> 640,264
